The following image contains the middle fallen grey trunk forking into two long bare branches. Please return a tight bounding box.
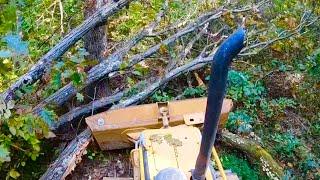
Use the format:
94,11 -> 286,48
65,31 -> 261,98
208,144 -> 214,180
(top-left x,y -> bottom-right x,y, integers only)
33,1 -> 267,119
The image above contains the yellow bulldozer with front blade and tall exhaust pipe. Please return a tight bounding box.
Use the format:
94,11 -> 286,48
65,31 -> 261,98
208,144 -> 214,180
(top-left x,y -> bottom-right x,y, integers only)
86,27 -> 245,180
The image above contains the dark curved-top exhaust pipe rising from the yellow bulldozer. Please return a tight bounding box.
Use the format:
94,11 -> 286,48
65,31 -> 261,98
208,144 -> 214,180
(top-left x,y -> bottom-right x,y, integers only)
192,28 -> 245,180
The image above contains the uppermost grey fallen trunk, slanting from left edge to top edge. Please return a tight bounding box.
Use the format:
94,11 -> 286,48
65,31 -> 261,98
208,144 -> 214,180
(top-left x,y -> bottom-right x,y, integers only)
0,0 -> 130,102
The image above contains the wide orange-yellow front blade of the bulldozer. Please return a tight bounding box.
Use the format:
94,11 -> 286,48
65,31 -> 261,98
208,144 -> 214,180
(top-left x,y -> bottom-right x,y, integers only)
86,98 -> 233,150
